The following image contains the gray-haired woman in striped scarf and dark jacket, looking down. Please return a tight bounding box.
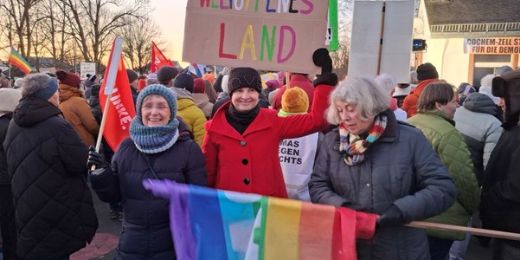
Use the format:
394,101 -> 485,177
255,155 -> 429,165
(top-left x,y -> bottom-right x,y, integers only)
309,78 -> 456,259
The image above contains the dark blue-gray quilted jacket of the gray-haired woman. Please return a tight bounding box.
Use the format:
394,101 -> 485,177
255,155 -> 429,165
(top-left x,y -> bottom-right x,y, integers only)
309,110 -> 456,260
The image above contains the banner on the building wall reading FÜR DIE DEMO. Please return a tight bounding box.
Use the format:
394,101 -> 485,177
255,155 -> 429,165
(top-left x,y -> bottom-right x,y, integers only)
464,37 -> 520,54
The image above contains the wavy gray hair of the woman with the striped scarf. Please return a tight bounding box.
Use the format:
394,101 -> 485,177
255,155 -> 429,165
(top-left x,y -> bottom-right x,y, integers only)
326,77 -> 390,125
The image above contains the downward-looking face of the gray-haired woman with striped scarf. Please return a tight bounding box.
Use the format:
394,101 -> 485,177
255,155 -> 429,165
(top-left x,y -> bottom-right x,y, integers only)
335,101 -> 375,135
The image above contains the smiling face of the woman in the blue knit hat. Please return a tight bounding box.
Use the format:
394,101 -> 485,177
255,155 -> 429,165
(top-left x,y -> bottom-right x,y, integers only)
141,95 -> 171,126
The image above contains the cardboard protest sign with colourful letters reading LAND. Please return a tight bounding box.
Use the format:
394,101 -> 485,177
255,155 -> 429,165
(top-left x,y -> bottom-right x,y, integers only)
183,0 -> 328,73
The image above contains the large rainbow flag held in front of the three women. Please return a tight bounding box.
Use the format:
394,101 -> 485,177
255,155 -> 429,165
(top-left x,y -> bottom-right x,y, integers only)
143,180 -> 377,260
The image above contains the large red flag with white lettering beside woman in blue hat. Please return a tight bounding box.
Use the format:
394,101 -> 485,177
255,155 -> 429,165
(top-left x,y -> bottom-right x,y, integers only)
99,55 -> 135,151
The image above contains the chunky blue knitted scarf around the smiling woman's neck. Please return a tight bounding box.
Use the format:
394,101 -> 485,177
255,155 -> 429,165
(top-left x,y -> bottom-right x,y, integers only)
130,116 -> 179,154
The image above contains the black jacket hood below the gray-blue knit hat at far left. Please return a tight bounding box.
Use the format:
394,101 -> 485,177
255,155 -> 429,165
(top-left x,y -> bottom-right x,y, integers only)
13,97 -> 61,127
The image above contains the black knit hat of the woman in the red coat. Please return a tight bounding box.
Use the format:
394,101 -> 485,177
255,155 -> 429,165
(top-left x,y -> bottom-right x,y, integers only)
228,67 -> 262,95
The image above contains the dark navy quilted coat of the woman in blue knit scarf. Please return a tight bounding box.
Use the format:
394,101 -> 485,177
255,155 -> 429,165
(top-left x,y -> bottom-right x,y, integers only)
90,121 -> 207,260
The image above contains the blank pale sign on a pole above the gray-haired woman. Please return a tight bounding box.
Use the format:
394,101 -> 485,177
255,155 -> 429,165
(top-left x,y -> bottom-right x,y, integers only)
348,0 -> 414,82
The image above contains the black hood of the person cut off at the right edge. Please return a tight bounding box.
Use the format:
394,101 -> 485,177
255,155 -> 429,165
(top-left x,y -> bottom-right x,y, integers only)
492,70 -> 520,129
